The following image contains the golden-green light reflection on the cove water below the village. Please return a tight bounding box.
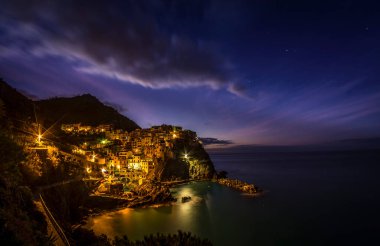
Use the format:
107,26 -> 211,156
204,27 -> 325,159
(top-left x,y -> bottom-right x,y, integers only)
85,182 -> 218,240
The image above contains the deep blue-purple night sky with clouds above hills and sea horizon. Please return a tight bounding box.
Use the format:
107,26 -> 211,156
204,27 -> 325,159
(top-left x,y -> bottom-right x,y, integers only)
0,0 -> 380,145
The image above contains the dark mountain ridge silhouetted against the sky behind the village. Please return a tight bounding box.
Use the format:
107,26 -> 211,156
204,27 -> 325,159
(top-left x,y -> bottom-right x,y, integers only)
0,80 -> 140,131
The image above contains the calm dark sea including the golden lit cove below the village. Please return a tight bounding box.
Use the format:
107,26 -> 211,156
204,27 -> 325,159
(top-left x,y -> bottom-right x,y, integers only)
87,151 -> 380,245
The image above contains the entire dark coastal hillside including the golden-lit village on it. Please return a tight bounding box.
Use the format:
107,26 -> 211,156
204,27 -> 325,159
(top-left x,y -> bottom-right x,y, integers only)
0,80 -> 216,245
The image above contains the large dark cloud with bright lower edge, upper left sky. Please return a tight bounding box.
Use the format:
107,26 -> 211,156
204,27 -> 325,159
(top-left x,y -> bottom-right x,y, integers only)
0,0 -> 238,90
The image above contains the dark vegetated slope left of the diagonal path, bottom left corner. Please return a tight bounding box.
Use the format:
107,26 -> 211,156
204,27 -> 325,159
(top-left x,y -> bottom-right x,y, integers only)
0,133 -> 52,245
